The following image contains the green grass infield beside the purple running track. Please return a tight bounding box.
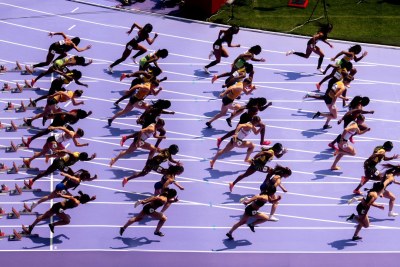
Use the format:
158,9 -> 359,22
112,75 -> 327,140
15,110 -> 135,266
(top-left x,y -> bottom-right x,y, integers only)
206,0 -> 400,46
